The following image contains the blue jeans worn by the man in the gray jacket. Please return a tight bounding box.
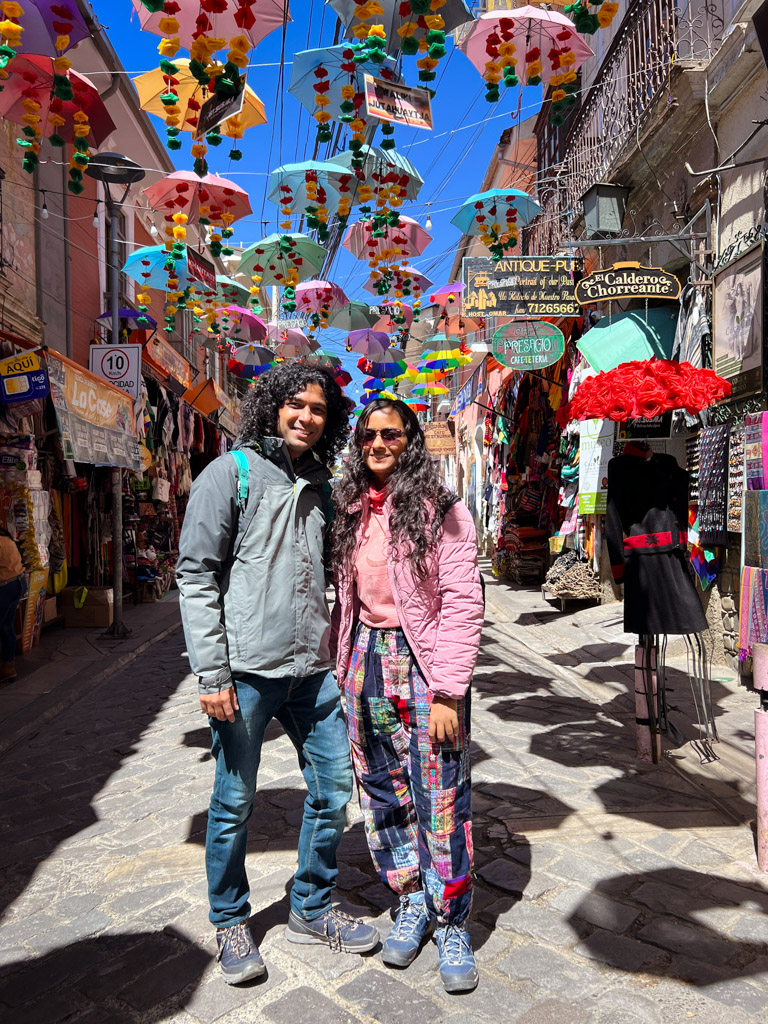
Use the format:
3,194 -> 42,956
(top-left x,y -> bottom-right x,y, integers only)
206,672 -> 352,928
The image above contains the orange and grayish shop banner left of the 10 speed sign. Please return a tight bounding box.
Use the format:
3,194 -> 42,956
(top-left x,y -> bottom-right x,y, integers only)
47,351 -> 139,471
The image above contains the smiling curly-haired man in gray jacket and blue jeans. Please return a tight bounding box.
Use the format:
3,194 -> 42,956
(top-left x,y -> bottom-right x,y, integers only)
176,364 -> 378,984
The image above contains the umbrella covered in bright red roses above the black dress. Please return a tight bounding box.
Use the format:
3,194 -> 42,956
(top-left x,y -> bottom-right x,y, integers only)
557,359 -> 731,423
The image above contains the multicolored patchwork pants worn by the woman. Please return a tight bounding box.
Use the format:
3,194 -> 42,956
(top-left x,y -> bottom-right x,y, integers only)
345,624 -> 472,925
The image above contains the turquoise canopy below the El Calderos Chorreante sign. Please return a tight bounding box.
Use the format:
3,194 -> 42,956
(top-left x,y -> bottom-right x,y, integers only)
577,306 -> 678,370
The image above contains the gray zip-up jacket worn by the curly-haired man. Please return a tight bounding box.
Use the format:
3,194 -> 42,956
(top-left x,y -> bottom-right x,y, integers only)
176,437 -> 331,692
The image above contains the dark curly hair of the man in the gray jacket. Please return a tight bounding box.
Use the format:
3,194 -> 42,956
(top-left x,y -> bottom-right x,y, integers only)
238,360 -> 349,468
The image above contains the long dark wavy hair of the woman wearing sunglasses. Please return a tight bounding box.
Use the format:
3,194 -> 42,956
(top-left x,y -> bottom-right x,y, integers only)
331,398 -> 458,579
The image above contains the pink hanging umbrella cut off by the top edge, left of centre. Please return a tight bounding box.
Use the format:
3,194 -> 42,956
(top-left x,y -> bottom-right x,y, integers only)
133,0 -> 288,50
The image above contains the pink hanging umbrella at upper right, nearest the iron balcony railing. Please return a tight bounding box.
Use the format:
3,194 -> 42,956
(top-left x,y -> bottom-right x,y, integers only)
460,5 -> 594,114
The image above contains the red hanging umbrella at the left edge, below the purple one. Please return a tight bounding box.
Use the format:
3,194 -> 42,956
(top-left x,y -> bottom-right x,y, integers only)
0,53 -> 115,146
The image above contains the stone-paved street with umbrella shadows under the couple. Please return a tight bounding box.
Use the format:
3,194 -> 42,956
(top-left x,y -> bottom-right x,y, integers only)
0,580 -> 768,1024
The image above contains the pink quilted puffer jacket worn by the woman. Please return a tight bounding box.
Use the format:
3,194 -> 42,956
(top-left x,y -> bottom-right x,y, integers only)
331,495 -> 484,698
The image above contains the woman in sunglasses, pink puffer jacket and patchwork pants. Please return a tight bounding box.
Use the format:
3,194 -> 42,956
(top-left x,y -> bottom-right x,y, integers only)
332,398 -> 483,992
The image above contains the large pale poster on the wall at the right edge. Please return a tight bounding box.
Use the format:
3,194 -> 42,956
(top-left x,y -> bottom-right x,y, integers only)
712,243 -> 764,398
